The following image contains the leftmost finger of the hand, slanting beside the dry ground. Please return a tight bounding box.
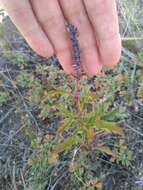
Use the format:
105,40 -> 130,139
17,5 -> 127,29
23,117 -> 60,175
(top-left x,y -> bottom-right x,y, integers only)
1,0 -> 54,57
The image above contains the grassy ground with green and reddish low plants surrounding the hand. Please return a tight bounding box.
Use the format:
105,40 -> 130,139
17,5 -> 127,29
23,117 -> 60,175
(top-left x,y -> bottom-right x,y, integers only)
0,0 -> 143,190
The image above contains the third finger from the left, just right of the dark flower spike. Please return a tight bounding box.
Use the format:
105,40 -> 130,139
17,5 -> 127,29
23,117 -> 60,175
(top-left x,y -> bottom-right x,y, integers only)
59,0 -> 102,75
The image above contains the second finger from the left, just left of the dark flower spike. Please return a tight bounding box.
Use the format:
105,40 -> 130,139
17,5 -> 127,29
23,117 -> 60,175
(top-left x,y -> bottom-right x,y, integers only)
31,0 -> 73,74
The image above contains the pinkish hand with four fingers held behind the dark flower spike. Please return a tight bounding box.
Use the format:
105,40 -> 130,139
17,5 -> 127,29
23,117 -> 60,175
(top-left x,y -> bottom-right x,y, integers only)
0,0 -> 121,75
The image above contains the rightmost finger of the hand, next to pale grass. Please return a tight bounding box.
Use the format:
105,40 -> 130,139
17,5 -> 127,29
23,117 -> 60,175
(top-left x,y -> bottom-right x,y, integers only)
83,0 -> 121,66
